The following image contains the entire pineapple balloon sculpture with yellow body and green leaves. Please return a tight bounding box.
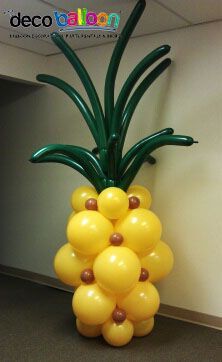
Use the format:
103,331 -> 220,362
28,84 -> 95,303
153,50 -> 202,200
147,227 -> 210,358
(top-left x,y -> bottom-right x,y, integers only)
31,0 -> 195,346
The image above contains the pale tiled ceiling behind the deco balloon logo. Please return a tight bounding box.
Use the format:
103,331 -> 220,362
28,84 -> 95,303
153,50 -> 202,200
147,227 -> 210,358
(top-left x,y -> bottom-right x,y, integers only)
0,0 -> 222,55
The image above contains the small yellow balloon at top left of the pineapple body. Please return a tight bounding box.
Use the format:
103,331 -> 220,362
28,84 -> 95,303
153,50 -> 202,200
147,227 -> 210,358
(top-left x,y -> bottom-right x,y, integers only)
71,186 -> 98,212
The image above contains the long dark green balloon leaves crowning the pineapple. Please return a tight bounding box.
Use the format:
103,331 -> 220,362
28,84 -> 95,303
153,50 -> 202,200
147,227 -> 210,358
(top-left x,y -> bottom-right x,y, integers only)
30,0 -> 195,192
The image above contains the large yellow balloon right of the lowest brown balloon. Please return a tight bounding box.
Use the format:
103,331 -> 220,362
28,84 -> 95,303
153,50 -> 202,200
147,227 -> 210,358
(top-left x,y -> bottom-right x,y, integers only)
117,282 -> 160,322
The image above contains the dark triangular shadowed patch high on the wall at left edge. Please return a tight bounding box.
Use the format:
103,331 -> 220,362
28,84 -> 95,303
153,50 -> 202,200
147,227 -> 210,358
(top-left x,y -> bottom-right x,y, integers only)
0,78 -> 42,107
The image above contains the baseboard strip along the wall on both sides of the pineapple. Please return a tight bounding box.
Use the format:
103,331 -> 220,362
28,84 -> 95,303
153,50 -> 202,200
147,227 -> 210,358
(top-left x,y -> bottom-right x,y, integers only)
0,264 -> 222,330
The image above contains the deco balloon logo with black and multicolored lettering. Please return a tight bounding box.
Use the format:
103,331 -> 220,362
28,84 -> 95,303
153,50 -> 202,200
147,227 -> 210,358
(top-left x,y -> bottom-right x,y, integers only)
4,8 -> 120,32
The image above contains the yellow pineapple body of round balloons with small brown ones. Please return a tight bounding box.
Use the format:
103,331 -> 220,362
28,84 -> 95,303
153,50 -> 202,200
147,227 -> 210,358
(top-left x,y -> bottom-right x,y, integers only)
54,185 -> 173,346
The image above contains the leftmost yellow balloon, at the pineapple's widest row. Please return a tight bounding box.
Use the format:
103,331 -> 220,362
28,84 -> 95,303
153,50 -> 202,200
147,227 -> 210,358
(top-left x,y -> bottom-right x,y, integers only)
54,243 -> 93,287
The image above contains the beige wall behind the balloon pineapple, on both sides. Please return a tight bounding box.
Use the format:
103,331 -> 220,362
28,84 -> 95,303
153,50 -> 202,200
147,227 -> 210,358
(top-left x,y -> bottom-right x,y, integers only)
0,22 -> 222,316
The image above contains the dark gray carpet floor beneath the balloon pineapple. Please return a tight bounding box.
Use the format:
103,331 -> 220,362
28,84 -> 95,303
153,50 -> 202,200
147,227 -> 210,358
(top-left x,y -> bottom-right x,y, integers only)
0,275 -> 222,362
